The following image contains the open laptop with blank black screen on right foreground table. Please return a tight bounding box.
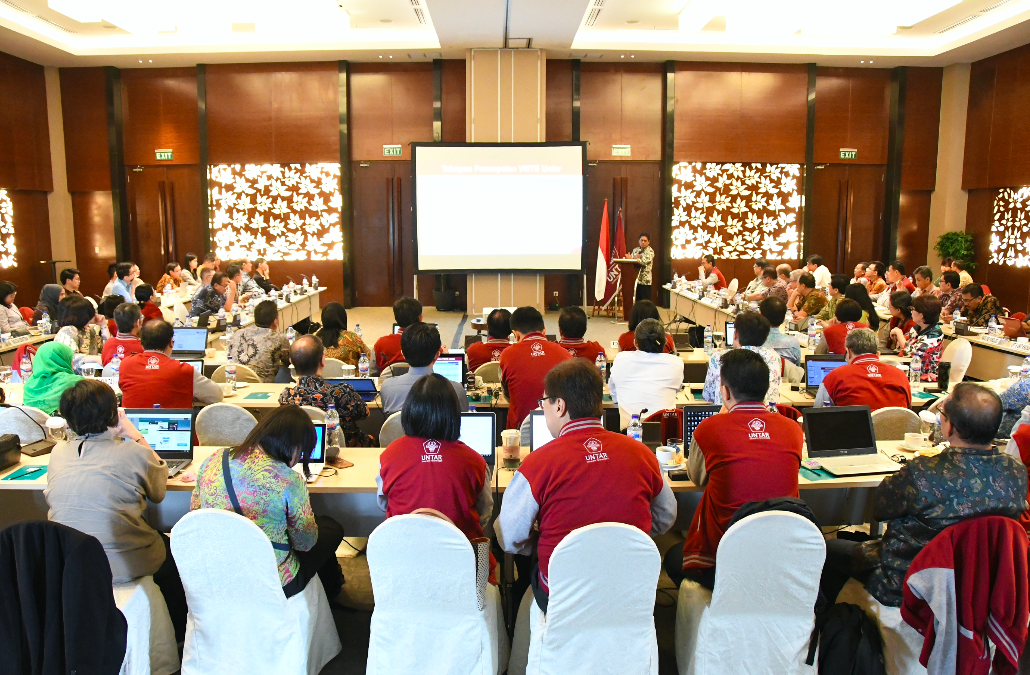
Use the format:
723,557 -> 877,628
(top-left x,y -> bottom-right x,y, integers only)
801,405 -> 901,476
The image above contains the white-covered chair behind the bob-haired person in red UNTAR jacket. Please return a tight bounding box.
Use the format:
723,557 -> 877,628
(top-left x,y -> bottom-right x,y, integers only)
366,514 -> 506,675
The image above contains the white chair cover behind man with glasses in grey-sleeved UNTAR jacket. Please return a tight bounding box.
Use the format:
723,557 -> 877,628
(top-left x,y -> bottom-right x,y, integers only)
525,522 -> 661,675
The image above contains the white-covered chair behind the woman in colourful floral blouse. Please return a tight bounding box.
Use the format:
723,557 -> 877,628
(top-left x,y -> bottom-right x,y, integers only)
172,509 -> 343,675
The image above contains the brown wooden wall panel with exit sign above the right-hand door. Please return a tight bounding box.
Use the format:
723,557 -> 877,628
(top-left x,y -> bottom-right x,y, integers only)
815,68 -> 891,164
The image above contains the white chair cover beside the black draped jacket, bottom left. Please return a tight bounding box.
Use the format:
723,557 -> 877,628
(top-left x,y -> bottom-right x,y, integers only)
113,576 -> 179,675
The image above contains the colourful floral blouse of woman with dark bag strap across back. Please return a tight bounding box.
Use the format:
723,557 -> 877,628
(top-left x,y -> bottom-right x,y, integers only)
190,448 -> 318,586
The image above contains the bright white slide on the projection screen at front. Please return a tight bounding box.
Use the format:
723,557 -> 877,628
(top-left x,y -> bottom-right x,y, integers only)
413,144 -> 585,272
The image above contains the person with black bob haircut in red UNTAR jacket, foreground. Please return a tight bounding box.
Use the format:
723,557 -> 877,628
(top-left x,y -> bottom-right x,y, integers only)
376,373 -> 496,584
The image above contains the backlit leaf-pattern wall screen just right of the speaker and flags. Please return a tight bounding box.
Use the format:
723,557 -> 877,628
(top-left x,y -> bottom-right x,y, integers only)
672,162 -> 801,260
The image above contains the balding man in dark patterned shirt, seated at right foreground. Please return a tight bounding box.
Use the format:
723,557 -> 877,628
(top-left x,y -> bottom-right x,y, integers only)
822,383 -> 1027,607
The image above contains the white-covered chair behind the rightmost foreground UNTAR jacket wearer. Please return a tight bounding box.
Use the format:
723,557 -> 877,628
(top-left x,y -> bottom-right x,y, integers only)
676,511 -> 826,675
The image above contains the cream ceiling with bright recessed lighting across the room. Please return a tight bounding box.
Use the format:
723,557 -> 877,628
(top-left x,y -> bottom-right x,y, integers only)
0,0 -> 1030,68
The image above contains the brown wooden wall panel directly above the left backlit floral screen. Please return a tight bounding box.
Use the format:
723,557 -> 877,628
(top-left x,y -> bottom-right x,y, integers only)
207,62 -> 340,164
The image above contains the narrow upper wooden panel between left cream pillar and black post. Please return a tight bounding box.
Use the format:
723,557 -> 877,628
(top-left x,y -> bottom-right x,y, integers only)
60,68 -> 113,192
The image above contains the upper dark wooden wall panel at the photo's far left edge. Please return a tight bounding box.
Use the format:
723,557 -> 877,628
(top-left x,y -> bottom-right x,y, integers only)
0,53 -> 54,192
